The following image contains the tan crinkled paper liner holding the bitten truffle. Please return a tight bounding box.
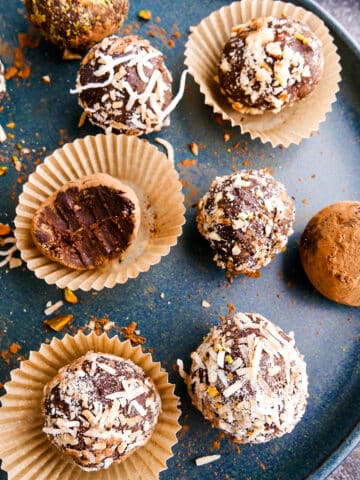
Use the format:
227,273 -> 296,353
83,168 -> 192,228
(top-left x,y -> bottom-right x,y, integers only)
15,134 -> 185,291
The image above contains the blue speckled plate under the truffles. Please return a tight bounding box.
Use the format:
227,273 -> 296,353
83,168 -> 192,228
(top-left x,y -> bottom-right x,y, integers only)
0,0 -> 360,480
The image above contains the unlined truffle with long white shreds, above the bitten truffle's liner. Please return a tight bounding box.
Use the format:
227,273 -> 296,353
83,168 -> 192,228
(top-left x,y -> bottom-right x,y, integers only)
72,35 -> 172,135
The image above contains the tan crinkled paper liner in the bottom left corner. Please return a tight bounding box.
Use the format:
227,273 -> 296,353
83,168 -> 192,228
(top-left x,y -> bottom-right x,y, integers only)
0,332 -> 180,480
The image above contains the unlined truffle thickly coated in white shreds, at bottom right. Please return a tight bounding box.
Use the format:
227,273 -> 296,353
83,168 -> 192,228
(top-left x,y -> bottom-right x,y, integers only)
187,313 -> 308,443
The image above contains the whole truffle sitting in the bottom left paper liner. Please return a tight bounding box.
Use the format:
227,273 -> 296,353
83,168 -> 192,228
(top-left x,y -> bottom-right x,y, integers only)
43,352 -> 161,471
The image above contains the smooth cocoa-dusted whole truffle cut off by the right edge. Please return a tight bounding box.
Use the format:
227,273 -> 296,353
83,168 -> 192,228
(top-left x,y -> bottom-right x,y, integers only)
300,201 -> 360,307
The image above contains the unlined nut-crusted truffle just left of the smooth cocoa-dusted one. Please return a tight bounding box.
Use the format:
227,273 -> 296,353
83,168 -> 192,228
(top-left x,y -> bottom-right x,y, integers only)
197,169 -> 295,275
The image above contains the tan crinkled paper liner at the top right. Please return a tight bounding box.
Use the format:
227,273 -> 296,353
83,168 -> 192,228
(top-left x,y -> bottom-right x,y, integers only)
185,0 -> 341,147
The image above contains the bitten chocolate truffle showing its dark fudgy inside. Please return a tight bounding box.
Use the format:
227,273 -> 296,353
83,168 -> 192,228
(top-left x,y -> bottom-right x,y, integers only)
31,173 -> 140,270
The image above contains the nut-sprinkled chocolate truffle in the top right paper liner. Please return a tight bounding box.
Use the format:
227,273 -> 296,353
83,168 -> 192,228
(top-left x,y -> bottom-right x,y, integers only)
218,17 -> 324,114
